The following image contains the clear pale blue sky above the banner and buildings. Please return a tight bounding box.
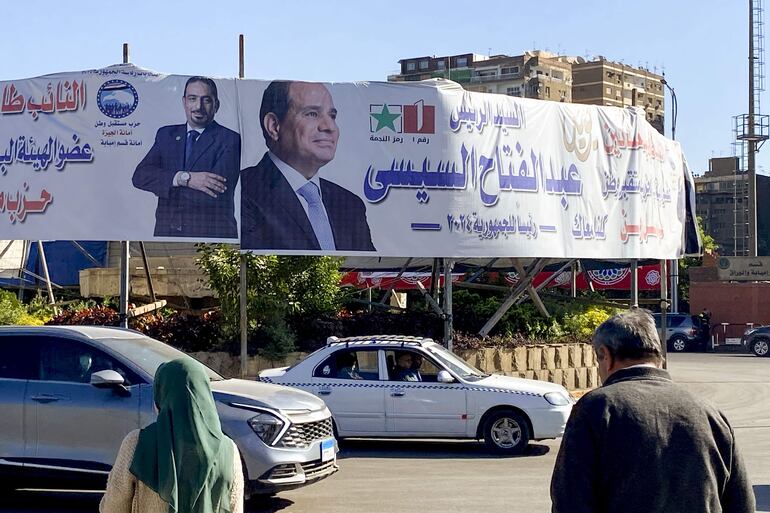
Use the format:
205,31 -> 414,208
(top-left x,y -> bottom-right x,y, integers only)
0,0 -> 770,173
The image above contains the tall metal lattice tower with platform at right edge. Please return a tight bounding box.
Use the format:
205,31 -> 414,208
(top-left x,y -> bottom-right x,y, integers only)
733,0 -> 770,256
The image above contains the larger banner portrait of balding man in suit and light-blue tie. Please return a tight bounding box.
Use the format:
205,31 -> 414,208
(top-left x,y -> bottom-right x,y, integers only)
241,81 -> 375,251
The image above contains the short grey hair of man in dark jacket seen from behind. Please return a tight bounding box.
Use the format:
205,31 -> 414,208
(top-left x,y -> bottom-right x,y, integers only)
593,308 -> 662,360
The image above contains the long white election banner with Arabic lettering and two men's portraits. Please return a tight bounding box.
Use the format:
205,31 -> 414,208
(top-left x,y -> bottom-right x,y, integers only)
0,65 -> 694,259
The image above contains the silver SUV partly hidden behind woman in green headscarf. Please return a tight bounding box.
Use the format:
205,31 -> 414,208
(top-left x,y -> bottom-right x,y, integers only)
0,326 -> 337,495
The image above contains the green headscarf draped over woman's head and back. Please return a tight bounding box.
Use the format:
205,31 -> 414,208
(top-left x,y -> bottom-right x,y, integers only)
130,358 -> 235,513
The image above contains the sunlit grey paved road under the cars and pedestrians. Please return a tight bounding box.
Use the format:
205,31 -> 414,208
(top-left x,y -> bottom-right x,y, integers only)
6,354 -> 770,513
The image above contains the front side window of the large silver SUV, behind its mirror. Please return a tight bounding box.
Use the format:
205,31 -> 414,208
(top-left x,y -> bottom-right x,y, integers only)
39,337 -> 139,385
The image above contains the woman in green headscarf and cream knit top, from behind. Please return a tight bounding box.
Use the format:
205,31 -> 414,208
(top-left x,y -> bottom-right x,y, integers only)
99,358 -> 243,513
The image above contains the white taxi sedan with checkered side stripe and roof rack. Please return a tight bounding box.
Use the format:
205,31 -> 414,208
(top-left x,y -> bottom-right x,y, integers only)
259,335 -> 573,454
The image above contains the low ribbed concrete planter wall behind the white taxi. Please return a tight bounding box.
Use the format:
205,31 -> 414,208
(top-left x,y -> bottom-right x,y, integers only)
192,344 -> 599,390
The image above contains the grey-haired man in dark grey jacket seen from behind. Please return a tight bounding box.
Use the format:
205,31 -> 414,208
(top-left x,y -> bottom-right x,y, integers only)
551,309 -> 754,513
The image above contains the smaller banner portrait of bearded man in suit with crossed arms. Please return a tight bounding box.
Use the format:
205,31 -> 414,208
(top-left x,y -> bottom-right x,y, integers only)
132,77 -> 241,239
